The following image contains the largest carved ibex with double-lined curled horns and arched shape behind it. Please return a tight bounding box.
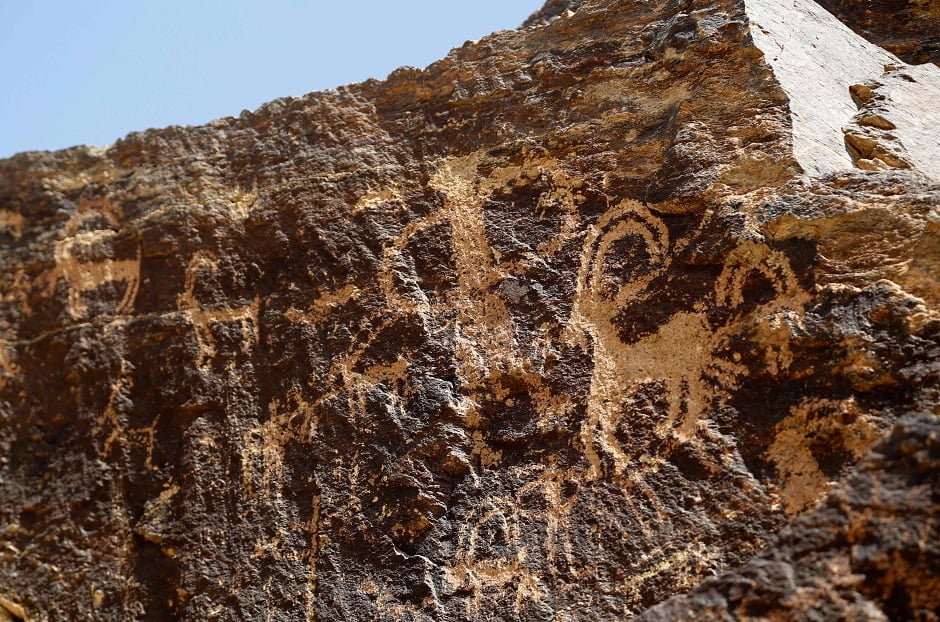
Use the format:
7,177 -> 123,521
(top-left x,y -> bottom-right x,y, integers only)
566,201 -> 805,478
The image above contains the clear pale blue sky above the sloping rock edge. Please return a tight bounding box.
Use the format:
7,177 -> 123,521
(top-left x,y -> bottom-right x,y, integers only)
0,0 -> 542,157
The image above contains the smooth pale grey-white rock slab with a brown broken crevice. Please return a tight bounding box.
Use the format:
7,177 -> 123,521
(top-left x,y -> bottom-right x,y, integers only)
747,0 -> 940,181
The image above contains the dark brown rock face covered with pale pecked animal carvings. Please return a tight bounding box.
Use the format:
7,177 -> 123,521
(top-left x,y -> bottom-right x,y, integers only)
0,0 -> 940,620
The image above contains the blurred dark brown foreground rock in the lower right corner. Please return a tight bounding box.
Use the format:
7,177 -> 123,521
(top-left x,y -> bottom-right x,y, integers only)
636,416 -> 940,621
